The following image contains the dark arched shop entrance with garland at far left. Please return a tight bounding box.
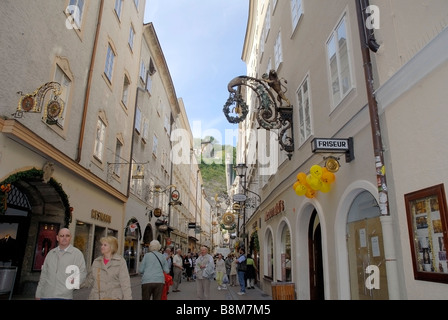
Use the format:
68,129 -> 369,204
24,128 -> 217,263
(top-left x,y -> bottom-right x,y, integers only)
0,168 -> 71,295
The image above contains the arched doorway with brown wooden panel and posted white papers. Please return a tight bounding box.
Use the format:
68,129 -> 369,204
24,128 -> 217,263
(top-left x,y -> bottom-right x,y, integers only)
346,191 -> 389,300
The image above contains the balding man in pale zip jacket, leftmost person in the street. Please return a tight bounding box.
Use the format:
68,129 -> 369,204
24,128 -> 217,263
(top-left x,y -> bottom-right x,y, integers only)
35,228 -> 87,300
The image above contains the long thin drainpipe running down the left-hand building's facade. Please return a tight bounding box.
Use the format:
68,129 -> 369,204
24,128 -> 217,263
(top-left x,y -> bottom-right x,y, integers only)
76,0 -> 104,163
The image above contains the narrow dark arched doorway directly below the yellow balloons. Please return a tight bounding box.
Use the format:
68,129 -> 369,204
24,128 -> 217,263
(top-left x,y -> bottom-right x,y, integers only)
308,210 -> 325,300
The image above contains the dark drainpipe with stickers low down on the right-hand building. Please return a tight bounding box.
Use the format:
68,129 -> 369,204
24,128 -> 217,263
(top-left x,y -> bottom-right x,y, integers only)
356,0 -> 400,300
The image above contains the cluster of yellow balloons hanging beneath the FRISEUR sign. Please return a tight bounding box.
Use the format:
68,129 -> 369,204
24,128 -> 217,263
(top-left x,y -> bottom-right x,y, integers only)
292,164 -> 336,199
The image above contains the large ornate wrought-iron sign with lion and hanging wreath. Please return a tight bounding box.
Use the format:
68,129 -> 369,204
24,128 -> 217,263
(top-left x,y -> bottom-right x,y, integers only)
223,70 -> 294,160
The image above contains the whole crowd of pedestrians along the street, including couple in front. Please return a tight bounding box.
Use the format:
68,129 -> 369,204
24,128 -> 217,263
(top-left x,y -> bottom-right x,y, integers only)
35,228 -> 257,300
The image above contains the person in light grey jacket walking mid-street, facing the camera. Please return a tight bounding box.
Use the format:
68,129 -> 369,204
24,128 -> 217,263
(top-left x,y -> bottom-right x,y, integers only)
194,246 -> 215,300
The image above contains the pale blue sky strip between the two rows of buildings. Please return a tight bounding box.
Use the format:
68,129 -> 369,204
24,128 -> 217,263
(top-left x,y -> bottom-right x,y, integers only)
144,0 -> 249,145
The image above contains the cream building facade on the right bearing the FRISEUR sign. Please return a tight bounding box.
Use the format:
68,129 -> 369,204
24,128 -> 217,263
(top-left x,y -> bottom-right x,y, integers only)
234,0 -> 448,300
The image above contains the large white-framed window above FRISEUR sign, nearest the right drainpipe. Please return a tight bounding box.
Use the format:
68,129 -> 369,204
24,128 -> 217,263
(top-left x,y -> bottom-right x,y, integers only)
327,16 -> 353,107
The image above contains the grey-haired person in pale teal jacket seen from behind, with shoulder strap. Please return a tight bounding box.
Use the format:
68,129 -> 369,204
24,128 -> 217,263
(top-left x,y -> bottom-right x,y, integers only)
139,240 -> 170,300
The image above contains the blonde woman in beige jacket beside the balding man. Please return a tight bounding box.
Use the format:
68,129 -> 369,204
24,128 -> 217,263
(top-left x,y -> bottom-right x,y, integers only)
86,236 -> 132,300
